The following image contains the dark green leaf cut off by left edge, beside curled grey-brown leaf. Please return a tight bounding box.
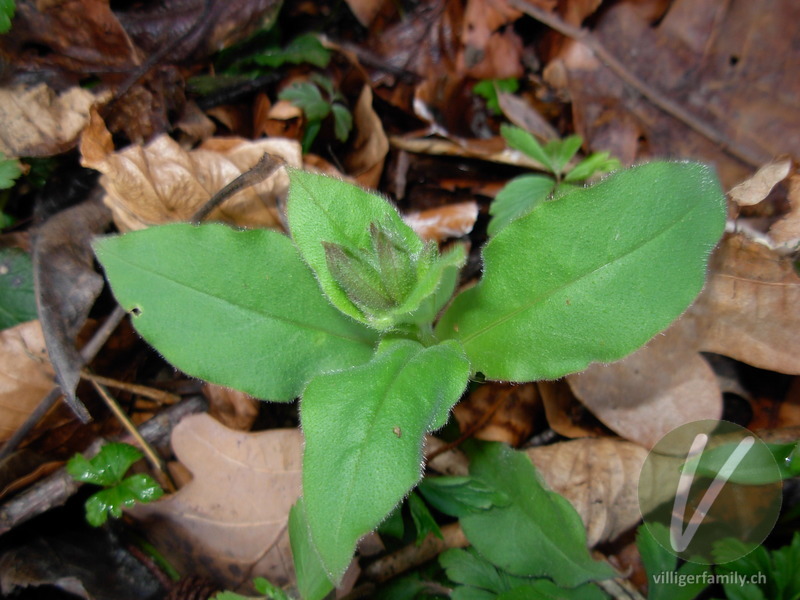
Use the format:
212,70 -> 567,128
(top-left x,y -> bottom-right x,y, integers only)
0,248 -> 38,329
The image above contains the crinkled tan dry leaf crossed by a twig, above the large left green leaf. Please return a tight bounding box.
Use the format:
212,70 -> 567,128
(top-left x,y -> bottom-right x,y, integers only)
81,114 -> 302,231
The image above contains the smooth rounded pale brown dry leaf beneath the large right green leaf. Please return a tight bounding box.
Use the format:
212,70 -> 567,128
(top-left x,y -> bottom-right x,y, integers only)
567,330 -> 722,448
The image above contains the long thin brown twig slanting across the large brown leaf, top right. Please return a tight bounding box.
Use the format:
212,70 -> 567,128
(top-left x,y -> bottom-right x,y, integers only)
508,0 -> 769,168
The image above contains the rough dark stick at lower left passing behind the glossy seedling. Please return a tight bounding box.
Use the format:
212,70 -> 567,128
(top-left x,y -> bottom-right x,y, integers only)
0,396 -> 208,535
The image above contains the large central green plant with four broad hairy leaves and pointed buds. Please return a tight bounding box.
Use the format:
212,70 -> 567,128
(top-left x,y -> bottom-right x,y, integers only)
95,156 -> 725,598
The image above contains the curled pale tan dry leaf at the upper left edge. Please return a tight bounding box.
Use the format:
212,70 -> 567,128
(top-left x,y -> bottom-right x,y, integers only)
0,83 -> 111,157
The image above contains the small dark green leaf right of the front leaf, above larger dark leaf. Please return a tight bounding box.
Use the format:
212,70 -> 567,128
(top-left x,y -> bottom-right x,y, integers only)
417,477 -> 508,517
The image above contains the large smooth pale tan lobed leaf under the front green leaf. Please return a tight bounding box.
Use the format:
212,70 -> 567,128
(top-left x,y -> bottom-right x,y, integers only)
130,414 -> 302,589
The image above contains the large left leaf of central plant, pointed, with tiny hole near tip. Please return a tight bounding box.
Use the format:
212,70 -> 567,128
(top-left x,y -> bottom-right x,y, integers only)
94,223 -> 376,400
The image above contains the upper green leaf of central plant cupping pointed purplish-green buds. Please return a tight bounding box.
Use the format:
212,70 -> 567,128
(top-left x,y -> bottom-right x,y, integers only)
287,169 -> 456,330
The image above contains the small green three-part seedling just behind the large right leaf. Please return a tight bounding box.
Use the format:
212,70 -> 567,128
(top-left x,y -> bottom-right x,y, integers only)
488,125 -> 620,235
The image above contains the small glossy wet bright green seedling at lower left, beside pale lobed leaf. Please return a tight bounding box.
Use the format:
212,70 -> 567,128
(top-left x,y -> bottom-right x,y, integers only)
67,442 -> 164,527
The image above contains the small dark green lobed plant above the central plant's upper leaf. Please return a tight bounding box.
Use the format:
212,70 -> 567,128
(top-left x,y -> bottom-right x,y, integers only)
278,73 -> 353,152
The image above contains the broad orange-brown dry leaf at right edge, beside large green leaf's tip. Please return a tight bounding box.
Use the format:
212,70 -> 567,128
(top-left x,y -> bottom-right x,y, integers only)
676,235 -> 800,375
